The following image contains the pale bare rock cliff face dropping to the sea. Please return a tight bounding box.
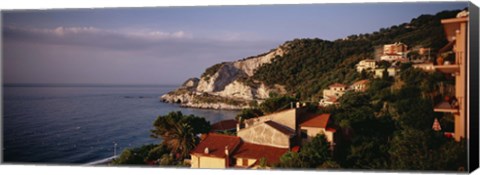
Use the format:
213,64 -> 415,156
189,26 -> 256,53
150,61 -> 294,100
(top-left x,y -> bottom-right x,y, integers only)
160,44 -> 285,109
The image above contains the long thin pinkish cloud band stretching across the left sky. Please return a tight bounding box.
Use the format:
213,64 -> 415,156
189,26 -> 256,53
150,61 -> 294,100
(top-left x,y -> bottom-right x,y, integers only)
3,26 -> 280,59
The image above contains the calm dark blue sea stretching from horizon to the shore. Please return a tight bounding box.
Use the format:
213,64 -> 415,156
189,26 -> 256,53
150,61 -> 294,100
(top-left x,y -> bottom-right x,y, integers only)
3,86 -> 237,164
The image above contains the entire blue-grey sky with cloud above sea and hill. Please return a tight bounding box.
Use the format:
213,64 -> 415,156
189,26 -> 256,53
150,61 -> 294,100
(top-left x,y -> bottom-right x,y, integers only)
2,2 -> 467,85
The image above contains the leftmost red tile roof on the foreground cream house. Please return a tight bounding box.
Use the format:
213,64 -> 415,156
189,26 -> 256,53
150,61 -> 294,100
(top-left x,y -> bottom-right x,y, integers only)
190,133 -> 241,158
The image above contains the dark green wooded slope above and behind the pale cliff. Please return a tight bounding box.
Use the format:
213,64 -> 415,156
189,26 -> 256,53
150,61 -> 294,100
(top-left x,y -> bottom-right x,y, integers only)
250,10 -> 459,100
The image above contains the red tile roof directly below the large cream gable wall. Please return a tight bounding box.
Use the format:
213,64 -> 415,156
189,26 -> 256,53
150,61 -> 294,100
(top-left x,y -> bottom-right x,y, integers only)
233,142 -> 288,165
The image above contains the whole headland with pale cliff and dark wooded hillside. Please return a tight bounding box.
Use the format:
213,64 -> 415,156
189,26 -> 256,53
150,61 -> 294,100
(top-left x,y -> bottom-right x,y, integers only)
161,10 -> 460,109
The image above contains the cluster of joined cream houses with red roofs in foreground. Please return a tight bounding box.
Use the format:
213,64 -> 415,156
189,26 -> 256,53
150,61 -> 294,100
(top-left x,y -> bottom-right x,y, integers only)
190,108 -> 335,168
